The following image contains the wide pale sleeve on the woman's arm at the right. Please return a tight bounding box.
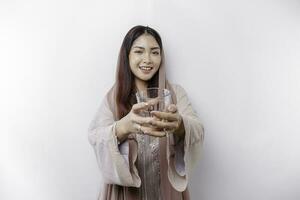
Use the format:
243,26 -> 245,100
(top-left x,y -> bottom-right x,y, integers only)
167,85 -> 204,191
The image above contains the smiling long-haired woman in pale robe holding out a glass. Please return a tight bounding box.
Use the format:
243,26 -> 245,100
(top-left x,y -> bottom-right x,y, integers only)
89,26 -> 204,200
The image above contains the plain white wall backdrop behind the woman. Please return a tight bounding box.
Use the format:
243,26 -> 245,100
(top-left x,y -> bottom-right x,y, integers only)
0,0 -> 300,200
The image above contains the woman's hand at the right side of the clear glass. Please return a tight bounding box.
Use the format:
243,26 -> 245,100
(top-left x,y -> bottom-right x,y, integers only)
151,104 -> 184,137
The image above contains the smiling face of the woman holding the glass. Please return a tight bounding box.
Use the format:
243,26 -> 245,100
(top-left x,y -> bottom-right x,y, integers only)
129,34 -> 161,81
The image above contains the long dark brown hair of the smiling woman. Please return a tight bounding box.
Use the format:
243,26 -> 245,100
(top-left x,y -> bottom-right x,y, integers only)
116,26 -> 164,119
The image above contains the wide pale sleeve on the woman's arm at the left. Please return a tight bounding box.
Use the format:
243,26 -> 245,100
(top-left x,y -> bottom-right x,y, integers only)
88,95 -> 141,187
